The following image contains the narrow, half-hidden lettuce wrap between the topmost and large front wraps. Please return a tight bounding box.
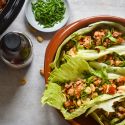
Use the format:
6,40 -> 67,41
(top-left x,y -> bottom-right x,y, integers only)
89,50 -> 125,75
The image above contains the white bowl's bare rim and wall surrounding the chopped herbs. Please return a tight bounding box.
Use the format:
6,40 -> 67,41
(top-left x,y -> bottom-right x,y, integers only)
25,0 -> 69,32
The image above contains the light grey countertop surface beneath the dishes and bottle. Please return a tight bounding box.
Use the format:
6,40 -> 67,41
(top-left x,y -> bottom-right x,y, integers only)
0,0 -> 125,125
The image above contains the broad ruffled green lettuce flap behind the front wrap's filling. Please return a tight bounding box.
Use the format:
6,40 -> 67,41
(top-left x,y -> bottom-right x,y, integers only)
49,57 -> 93,83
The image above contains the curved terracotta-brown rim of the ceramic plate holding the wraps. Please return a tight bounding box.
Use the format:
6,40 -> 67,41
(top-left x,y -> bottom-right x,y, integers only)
44,16 -> 125,125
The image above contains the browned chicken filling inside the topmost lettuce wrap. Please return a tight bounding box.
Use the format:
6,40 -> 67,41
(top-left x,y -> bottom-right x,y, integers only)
65,28 -> 125,49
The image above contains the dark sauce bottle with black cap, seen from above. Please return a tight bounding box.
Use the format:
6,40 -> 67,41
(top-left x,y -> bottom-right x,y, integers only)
0,32 -> 33,68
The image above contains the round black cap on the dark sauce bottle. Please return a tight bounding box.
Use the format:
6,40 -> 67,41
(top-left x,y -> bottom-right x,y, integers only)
1,32 -> 21,51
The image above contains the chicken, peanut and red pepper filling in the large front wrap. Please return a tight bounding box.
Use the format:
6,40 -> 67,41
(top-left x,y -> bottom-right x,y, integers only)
62,76 -> 125,112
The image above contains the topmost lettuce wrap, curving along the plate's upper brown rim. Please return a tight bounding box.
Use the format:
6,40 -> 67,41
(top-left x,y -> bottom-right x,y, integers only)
51,21 -> 125,68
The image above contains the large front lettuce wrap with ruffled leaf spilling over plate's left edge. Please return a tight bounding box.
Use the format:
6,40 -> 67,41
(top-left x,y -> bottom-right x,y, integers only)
41,57 -> 124,120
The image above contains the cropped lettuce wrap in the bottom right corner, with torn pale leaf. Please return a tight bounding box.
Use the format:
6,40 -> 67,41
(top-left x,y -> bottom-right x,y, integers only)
87,96 -> 125,125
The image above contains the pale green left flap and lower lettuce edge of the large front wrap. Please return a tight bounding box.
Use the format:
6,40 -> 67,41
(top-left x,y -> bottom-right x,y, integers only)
41,82 -> 124,120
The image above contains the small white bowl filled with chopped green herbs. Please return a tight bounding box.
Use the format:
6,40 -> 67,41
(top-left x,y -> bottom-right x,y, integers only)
25,0 -> 69,32
